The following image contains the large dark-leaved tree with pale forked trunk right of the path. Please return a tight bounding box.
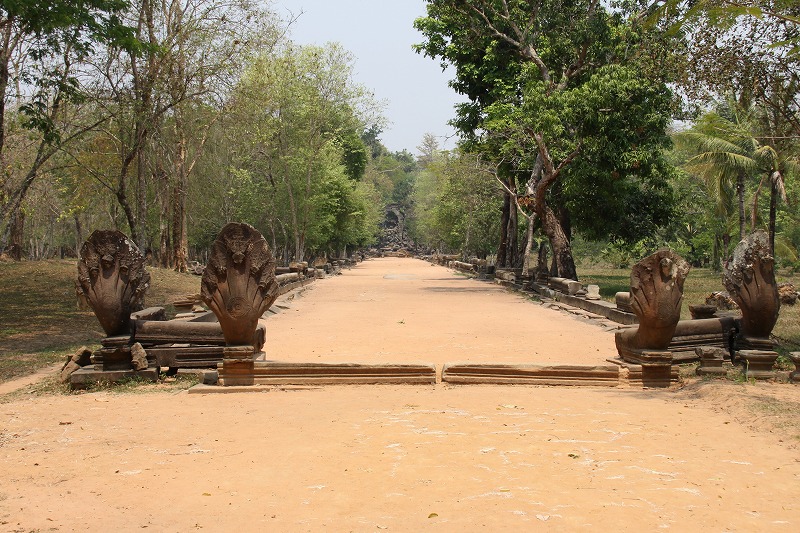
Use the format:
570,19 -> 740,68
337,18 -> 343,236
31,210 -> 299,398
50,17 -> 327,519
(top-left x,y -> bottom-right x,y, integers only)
415,0 -> 673,278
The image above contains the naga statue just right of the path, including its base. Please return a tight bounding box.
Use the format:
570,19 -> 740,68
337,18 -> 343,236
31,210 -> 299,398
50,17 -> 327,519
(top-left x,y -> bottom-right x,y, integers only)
615,250 -> 690,384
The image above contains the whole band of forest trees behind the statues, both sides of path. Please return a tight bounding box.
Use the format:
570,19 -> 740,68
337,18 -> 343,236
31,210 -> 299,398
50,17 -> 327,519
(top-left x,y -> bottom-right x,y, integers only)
0,0 -> 800,278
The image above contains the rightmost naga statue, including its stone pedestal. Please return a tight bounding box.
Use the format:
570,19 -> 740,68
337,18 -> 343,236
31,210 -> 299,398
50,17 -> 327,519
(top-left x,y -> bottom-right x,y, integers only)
722,230 -> 781,379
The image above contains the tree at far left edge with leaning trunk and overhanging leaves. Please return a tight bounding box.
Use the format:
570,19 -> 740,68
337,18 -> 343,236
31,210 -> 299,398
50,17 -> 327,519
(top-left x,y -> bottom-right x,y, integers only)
0,0 -> 139,257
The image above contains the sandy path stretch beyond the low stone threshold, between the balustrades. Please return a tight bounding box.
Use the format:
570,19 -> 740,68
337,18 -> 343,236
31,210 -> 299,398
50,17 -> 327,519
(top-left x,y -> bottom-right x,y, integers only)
265,258 -> 617,367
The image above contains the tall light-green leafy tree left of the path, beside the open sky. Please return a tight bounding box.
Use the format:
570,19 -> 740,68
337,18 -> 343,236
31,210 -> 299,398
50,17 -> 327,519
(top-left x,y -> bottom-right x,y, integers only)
233,45 -> 382,261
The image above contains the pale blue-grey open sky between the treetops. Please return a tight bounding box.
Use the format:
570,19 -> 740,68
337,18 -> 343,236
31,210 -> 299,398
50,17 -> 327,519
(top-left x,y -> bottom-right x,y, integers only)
271,0 -> 464,154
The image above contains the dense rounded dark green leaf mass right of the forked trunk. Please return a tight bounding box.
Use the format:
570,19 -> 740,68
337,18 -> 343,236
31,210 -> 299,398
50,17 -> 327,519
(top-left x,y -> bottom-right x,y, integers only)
552,65 -> 673,243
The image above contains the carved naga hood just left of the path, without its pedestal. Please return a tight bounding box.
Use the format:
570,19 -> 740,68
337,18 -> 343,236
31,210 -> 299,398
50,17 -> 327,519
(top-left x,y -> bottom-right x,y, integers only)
201,222 -> 278,346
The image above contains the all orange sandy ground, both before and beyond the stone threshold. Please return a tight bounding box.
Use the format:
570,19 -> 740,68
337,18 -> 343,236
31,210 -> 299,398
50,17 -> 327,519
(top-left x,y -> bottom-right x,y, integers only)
0,260 -> 800,532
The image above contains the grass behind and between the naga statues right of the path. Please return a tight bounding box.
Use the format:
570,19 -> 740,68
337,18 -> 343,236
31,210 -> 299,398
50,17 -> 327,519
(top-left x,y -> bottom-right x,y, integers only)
578,266 -> 800,351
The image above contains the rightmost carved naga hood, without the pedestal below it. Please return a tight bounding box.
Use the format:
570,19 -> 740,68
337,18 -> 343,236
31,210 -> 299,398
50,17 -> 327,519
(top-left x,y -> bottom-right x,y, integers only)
722,230 -> 781,339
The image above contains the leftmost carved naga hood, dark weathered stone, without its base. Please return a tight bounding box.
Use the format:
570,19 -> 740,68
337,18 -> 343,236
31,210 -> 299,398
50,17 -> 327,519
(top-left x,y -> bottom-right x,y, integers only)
78,230 -> 150,337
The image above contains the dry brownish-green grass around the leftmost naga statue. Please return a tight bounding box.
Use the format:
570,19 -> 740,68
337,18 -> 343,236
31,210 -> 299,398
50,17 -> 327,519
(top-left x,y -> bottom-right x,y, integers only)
0,260 -> 200,383
